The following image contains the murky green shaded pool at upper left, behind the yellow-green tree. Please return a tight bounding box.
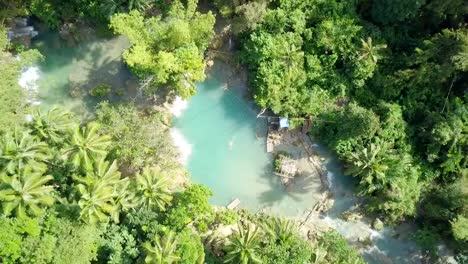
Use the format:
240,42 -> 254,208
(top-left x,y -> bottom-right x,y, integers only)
33,29 -> 137,115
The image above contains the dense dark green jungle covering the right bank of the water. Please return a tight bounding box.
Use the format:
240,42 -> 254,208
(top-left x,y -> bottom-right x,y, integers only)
234,0 -> 468,258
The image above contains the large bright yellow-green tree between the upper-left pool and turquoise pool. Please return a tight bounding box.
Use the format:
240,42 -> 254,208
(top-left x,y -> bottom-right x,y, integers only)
110,0 -> 215,98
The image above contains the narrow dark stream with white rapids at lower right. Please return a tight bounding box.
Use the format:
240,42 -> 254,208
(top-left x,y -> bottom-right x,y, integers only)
313,144 -> 421,264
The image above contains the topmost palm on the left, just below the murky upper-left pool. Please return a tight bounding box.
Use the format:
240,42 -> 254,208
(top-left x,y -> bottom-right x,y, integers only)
29,107 -> 74,144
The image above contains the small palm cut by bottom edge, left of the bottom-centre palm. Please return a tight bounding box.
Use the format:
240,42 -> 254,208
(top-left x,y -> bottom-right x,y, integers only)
143,230 -> 180,264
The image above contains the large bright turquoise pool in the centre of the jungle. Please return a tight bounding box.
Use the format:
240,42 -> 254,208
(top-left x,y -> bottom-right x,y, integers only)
174,67 -> 324,216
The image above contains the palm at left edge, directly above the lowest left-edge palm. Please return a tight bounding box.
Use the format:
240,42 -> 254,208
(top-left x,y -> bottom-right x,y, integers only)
0,129 -> 49,174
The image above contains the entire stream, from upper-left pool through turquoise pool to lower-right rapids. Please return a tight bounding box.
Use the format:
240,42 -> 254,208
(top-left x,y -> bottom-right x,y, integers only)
19,29 -> 424,263
